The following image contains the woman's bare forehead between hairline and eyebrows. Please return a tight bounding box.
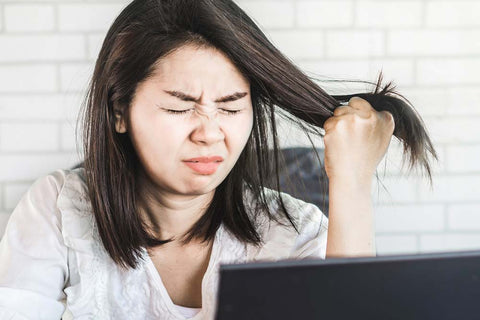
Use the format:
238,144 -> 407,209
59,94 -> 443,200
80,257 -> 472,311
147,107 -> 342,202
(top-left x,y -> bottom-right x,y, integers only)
148,45 -> 250,92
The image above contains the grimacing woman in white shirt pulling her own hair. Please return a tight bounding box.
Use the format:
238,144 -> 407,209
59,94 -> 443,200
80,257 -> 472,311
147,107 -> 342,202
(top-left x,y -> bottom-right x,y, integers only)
0,0 -> 436,319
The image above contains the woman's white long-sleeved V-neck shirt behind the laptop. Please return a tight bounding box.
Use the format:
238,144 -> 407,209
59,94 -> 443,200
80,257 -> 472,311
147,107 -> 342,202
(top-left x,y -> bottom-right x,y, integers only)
0,168 -> 328,320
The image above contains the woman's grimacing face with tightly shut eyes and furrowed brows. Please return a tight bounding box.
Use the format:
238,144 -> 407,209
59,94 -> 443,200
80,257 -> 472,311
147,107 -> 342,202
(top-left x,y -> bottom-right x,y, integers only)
117,46 -> 253,195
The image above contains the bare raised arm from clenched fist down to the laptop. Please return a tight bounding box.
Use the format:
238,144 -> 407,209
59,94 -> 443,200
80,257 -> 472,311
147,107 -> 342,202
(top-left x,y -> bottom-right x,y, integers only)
324,97 -> 395,258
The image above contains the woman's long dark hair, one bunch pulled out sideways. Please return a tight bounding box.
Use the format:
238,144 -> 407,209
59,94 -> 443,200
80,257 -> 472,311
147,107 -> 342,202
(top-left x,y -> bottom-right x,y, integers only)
83,0 -> 437,268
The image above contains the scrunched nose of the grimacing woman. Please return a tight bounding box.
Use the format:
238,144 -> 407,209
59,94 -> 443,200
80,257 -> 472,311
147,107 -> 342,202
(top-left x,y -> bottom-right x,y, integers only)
190,109 -> 225,145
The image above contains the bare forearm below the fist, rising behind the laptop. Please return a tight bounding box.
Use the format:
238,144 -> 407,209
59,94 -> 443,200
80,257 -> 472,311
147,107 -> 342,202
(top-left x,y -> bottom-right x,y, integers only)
327,179 -> 375,258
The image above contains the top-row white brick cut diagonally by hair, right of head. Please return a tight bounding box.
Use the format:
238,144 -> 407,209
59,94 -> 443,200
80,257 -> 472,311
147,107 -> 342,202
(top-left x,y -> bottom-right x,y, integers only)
238,0 -> 295,29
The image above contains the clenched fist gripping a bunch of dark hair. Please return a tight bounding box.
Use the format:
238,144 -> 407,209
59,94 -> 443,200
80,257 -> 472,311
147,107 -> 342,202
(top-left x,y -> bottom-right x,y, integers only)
323,97 -> 395,183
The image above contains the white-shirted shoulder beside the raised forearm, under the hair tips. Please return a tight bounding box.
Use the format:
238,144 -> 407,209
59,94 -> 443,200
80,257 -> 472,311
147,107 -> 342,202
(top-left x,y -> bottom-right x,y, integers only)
249,188 -> 328,260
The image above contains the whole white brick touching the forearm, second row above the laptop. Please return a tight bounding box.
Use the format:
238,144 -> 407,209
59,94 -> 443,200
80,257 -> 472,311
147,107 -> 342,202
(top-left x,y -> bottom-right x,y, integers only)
374,204 -> 445,233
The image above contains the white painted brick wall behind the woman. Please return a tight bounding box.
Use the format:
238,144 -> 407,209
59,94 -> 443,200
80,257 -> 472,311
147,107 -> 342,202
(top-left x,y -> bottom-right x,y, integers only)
0,0 -> 480,254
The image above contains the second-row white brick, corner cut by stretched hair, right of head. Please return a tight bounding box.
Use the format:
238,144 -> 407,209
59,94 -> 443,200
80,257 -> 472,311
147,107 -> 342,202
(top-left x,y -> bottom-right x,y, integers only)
270,31 -> 324,59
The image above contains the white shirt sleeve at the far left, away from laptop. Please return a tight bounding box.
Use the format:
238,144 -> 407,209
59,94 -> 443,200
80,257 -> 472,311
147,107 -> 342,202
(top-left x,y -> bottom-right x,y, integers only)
0,170 -> 69,320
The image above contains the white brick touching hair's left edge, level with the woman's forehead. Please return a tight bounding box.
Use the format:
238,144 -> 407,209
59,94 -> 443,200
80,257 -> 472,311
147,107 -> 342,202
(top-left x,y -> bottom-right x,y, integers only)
60,63 -> 94,93
